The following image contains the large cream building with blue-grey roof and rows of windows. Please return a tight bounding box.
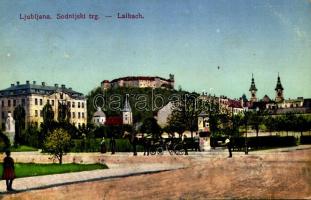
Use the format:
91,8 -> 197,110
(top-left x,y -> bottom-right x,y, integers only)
0,81 -> 87,129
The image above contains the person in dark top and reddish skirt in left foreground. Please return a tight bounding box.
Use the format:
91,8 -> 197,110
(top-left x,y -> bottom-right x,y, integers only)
2,151 -> 15,191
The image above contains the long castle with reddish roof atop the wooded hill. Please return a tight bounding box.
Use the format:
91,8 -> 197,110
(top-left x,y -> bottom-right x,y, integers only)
101,74 -> 175,90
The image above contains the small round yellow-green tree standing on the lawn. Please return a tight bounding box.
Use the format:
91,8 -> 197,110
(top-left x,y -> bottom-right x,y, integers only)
44,128 -> 71,164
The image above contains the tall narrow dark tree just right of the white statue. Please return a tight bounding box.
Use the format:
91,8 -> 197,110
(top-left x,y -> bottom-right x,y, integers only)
13,105 -> 26,146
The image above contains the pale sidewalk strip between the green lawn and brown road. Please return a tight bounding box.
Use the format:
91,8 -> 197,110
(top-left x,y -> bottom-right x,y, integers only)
0,164 -> 185,195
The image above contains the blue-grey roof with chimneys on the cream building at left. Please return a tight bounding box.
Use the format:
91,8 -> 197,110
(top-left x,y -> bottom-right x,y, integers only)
0,81 -> 84,99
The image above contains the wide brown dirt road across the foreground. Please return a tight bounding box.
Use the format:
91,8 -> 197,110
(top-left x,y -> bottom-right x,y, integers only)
3,149 -> 311,200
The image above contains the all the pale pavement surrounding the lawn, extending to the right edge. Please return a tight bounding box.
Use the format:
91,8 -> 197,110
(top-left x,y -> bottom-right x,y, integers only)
0,145 -> 311,197
